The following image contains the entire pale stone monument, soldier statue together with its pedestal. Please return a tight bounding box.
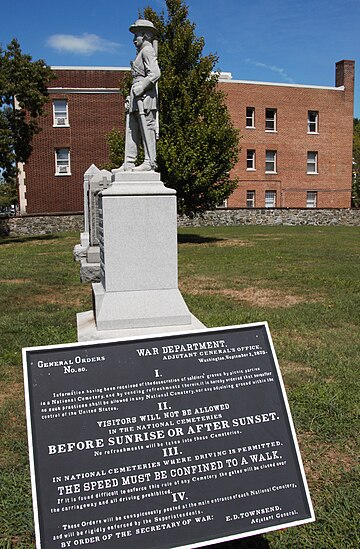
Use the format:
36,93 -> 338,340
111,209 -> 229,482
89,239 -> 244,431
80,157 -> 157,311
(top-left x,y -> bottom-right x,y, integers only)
77,19 -> 203,341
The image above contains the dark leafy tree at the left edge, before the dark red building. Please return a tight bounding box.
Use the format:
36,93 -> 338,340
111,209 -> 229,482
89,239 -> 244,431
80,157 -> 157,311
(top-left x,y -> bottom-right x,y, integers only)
0,38 -> 53,181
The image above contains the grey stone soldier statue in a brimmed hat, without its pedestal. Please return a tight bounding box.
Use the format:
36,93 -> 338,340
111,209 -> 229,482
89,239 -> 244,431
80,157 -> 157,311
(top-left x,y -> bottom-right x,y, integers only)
120,19 -> 160,171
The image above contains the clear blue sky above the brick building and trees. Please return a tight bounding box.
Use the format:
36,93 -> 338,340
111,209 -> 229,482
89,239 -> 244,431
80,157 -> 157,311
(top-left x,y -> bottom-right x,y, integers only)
0,0 -> 360,117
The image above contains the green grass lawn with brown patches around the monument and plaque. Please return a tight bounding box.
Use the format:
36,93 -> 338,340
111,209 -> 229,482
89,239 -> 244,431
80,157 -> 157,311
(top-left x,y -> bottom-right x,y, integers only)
0,226 -> 360,549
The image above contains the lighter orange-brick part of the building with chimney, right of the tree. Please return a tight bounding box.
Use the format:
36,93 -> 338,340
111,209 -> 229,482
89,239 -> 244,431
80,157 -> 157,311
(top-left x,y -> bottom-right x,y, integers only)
220,61 -> 355,208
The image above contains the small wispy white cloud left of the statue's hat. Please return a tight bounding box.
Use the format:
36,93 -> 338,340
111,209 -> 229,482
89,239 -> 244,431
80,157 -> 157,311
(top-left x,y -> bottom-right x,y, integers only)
47,32 -> 120,55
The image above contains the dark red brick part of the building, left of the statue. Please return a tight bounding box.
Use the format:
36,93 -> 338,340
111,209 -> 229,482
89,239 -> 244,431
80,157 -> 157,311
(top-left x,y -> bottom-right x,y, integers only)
19,67 -> 129,214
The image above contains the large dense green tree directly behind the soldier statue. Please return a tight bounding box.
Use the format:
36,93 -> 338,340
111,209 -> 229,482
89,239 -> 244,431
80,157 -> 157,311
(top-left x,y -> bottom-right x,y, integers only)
109,0 -> 239,214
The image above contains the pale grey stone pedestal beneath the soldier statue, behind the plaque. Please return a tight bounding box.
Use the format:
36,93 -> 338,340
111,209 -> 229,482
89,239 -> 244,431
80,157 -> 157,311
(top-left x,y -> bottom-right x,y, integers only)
78,171 -> 203,341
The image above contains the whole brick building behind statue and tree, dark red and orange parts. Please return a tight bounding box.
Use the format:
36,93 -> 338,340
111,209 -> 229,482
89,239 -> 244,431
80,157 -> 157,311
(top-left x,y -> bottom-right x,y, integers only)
19,61 -> 355,214
